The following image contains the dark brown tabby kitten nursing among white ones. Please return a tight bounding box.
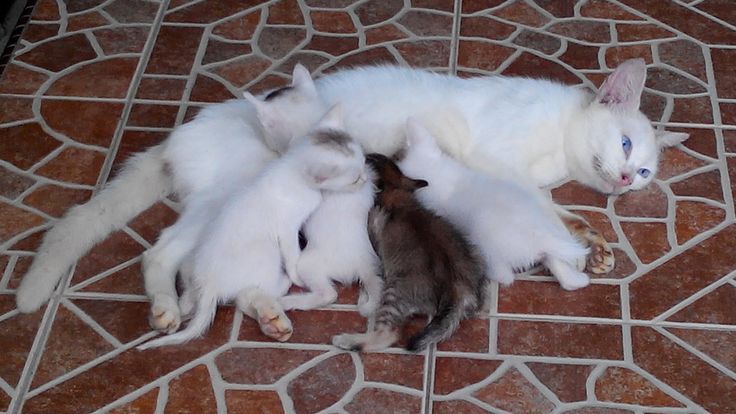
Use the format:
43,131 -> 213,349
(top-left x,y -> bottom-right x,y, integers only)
332,154 -> 487,351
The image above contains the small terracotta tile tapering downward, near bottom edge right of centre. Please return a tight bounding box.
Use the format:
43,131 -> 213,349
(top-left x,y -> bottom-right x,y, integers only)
526,362 -> 593,402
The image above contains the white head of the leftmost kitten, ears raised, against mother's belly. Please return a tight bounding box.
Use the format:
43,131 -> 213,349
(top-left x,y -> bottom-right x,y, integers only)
243,64 -> 327,153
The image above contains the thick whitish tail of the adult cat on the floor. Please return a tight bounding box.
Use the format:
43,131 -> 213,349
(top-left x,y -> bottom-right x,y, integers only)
15,144 -> 173,313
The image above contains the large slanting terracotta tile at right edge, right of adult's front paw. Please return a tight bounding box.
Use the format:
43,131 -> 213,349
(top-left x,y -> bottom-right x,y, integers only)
629,226 -> 736,319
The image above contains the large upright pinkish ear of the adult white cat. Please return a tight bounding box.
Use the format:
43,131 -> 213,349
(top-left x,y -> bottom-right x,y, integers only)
595,58 -> 647,112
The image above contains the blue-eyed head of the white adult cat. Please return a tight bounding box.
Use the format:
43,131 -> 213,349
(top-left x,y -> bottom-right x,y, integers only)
566,59 -> 688,194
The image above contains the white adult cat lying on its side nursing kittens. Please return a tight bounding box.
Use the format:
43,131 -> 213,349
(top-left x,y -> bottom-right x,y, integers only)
17,60 -> 687,329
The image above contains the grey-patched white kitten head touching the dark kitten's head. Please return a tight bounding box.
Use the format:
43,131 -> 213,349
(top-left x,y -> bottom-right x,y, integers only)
292,104 -> 366,191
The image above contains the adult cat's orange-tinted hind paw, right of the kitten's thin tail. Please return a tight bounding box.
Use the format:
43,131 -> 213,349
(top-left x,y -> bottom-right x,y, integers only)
235,288 -> 294,342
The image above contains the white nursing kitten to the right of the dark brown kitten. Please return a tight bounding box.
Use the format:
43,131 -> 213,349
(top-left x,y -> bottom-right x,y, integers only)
399,118 -> 590,290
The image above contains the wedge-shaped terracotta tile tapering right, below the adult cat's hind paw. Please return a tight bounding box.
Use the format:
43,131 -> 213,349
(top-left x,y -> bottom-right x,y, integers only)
215,348 -> 324,385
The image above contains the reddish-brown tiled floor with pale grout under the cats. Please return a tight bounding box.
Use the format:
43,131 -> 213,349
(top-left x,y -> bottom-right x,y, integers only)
0,0 -> 736,414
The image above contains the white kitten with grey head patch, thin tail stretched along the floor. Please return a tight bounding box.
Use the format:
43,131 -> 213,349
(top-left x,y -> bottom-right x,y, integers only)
139,108 -> 365,349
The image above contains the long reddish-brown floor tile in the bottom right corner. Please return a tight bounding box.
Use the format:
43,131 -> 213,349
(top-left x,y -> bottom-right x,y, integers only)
631,327 -> 736,412
